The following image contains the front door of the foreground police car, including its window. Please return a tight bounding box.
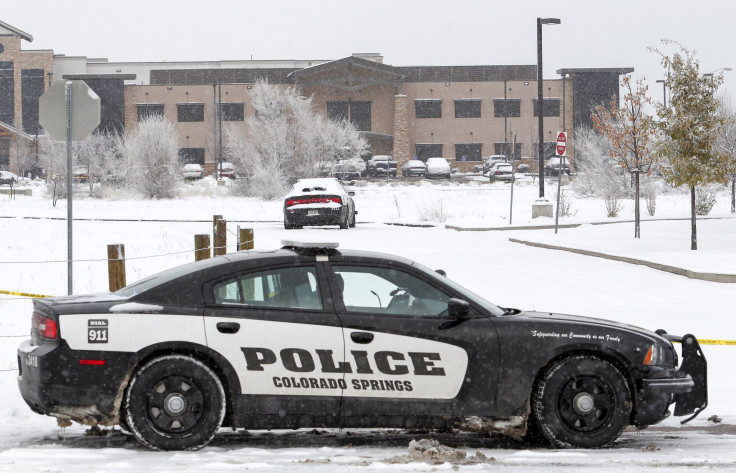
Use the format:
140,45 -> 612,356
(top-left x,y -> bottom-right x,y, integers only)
330,261 -> 498,427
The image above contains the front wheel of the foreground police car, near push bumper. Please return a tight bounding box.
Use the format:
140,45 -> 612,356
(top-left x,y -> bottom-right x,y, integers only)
531,355 -> 632,448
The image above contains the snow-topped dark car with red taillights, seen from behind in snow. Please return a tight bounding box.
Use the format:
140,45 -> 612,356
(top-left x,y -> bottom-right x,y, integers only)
284,177 -> 358,230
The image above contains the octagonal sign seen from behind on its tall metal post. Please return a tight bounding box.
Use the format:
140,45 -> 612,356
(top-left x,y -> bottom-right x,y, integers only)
38,80 -> 101,295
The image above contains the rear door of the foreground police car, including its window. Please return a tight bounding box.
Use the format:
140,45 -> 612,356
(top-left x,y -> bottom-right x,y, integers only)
205,263 -> 344,427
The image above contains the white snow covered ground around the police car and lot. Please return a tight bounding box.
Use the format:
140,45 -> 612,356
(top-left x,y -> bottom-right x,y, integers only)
0,175 -> 736,472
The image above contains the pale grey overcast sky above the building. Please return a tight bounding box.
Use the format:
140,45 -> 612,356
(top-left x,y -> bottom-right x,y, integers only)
5,0 -> 736,100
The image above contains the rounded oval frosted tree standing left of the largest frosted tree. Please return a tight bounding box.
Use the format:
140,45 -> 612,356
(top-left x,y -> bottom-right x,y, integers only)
122,115 -> 179,199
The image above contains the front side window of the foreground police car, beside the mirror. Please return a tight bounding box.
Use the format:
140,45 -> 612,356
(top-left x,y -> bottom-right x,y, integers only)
333,266 -> 450,317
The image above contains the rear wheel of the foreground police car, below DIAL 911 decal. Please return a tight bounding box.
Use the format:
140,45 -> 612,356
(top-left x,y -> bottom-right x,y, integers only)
125,355 -> 225,451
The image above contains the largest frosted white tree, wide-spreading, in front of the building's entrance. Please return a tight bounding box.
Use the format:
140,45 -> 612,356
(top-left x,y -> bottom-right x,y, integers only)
224,81 -> 367,199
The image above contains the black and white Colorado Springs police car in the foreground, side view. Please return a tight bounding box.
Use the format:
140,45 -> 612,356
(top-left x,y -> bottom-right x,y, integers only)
18,241 -> 707,450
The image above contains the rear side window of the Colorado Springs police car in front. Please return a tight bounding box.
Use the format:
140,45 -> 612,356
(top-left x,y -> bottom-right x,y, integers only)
213,266 -> 322,310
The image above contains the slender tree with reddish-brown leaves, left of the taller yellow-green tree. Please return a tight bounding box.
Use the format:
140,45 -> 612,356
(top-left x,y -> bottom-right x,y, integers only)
591,75 -> 654,238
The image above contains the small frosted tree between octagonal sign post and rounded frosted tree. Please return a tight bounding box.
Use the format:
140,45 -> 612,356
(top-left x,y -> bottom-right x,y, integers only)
75,132 -> 119,197
